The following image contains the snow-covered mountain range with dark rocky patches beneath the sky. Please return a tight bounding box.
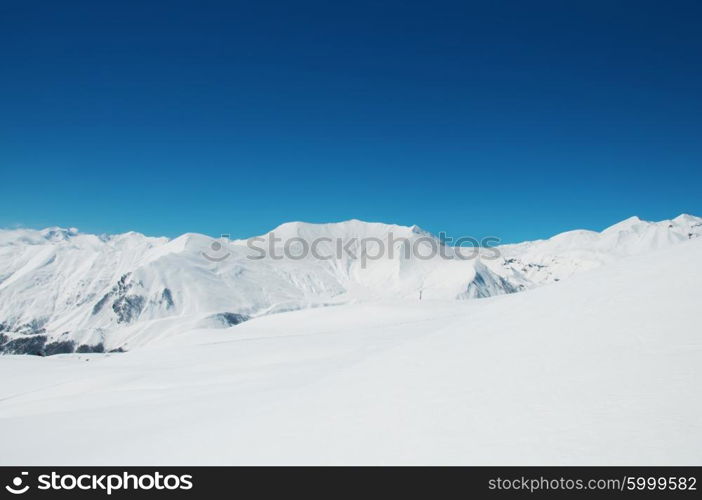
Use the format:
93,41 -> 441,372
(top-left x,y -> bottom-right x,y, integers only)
0,215 -> 702,355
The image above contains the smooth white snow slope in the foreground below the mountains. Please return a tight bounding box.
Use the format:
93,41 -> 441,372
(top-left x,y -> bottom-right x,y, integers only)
0,239 -> 702,465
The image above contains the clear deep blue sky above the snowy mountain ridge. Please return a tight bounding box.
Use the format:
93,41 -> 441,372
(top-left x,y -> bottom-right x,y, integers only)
0,0 -> 702,241
